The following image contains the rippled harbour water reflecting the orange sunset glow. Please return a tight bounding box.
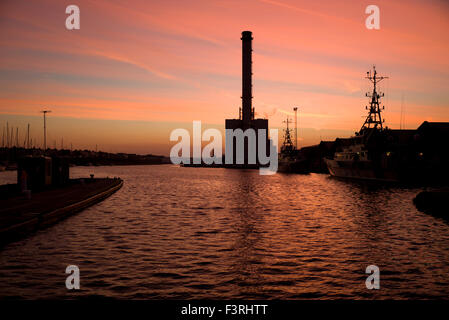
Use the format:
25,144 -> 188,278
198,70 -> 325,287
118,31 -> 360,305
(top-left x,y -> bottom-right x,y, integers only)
0,165 -> 449,299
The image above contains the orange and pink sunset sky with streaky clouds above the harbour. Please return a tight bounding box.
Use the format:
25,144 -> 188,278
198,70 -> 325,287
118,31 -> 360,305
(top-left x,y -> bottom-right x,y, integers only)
0,0 -> 449,155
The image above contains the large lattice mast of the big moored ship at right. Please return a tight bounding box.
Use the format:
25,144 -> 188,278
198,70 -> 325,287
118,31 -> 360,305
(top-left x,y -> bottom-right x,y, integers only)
360,66 -> 388,134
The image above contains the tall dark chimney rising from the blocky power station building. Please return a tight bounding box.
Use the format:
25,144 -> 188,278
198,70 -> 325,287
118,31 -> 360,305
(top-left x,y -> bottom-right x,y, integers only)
241,31 -> 253,128
